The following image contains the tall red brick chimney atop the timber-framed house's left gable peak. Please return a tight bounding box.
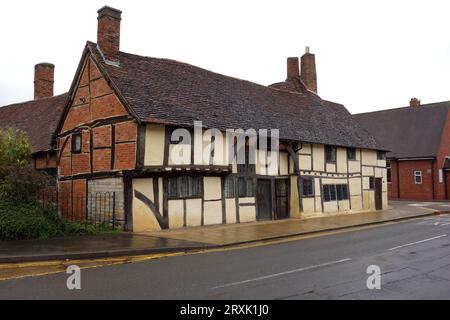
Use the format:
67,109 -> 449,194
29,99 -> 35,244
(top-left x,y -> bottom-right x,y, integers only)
97,6 -> 122,62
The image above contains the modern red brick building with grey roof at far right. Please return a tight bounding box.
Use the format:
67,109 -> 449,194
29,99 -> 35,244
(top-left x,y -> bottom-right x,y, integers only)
354,98 -> 450,200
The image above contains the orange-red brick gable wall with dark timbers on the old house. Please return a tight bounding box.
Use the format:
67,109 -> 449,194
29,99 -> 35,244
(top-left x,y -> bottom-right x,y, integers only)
59,57 -> 137,177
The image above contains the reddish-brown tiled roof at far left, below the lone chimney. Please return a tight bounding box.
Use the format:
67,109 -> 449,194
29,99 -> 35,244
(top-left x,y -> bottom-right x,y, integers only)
0,93 -> 68,153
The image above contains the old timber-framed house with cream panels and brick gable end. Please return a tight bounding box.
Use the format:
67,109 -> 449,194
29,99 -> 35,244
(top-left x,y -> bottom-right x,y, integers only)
55,7 -> 387,231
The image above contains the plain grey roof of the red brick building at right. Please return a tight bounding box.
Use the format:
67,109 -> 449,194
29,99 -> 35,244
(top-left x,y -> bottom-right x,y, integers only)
354,101 -> 450,159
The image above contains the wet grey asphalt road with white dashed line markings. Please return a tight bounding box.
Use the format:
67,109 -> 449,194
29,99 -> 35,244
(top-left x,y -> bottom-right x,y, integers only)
0,216 -> 450,299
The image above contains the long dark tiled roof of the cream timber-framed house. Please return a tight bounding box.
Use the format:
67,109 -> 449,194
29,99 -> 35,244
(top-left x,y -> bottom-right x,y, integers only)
62,42 -> 382,149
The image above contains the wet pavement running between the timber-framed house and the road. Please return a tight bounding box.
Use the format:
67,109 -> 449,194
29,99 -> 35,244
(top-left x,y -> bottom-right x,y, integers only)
0,201 -> 450,263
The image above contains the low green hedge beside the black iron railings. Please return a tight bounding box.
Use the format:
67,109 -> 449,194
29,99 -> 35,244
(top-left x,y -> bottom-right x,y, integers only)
0,200 -> 117,240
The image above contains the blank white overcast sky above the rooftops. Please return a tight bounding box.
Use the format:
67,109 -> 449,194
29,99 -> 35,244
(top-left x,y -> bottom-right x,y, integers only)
0,0 -> 450,113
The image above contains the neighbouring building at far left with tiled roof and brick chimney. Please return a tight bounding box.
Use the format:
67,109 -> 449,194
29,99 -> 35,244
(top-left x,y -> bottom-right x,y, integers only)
0,63 -> 67,172
